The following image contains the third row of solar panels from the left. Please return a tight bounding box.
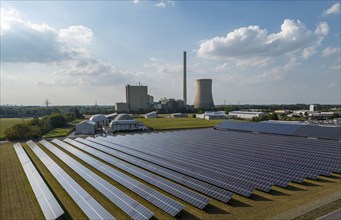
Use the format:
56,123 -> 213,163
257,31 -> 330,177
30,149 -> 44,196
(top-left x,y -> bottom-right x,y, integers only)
40,140 -> 154,219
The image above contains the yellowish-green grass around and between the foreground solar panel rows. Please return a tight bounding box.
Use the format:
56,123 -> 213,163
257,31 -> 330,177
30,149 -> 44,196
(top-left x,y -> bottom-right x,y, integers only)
0,138 -> 341,220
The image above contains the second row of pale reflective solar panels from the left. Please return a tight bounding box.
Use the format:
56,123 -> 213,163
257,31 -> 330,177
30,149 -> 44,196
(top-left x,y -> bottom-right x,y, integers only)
26,140 -> 115,219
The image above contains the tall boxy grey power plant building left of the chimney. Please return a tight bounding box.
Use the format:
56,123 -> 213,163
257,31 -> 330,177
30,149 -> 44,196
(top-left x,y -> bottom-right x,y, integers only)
126,85 -> 149,110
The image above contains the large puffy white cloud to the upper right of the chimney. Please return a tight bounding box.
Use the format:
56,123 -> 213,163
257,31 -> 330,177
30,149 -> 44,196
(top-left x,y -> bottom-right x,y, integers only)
197,19 -> 329,66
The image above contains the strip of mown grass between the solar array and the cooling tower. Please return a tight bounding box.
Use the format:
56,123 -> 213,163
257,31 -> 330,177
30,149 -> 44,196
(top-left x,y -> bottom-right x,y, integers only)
135,118 -> 224,130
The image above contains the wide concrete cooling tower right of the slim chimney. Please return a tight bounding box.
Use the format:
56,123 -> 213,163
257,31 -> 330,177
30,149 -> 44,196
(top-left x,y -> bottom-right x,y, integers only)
194,79 -> 214,108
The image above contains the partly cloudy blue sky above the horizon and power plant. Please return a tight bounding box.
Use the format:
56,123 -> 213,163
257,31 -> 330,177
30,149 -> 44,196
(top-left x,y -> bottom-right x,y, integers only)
1,0 -> 341,105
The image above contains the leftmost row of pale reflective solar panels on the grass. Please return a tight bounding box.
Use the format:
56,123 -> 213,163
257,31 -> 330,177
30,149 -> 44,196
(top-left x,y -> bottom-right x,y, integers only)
13,143 -> 64,219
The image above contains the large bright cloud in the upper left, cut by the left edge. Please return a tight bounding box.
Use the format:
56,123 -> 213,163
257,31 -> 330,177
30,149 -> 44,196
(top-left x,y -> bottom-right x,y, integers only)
1,8 -> 93,62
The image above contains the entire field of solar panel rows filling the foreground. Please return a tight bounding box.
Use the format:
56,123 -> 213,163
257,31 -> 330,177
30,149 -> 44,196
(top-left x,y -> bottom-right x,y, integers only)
14,122 -> 341,219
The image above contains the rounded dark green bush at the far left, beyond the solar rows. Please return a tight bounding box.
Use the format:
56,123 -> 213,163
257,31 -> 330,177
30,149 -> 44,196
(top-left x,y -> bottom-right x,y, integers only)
4,123 -> 41,140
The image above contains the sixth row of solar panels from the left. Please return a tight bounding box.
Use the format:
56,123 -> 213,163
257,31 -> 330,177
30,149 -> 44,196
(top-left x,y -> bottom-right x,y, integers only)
76,138 -> 233,202
